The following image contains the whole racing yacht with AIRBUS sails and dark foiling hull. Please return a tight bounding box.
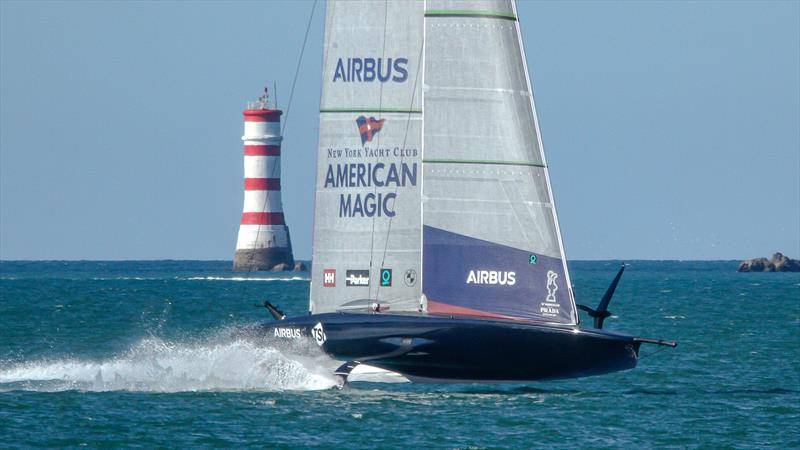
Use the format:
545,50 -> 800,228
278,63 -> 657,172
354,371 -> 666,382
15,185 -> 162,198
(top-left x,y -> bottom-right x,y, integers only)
263,0 -> 674,384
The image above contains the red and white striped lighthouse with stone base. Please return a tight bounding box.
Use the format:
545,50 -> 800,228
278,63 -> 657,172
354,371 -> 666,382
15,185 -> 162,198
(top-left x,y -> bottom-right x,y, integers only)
233,89 -> 294,271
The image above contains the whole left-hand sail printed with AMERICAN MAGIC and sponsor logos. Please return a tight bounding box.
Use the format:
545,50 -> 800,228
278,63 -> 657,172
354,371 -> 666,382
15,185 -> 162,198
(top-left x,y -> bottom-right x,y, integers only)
310,0 -> 424,313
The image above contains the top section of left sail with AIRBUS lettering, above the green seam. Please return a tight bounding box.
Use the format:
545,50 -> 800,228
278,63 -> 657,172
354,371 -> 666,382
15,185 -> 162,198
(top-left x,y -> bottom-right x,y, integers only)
320,0 -> 424,112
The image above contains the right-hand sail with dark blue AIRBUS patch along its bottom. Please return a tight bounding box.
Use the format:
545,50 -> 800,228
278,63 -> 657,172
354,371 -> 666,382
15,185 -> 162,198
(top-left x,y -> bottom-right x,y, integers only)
423,1 -> 577,323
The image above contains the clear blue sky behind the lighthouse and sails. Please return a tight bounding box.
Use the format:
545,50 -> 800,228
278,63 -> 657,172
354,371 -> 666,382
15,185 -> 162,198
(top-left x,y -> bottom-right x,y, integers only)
0,0 -> 800,259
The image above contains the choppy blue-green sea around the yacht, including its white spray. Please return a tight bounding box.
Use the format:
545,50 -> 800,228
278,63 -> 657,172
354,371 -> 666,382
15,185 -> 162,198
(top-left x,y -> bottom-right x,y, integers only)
0,261 -> 800,448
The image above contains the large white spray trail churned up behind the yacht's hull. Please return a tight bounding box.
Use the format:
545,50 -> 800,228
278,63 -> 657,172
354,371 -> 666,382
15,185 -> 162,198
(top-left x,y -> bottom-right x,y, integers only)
0,334 -> 338,392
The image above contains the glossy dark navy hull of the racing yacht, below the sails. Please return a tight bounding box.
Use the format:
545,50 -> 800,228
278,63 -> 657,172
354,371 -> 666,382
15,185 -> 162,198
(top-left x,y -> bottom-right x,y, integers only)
263,313 -> 641,382
